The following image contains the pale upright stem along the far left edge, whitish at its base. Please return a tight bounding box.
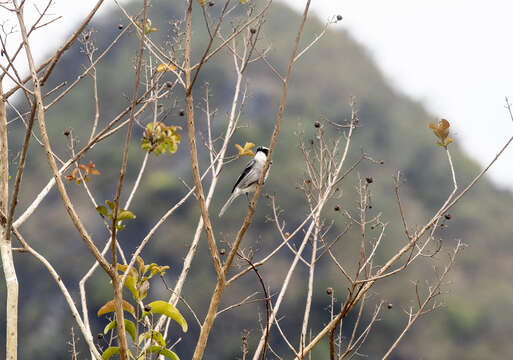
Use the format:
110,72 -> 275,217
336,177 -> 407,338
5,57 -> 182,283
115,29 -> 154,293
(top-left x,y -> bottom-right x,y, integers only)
0,82 -> 18,360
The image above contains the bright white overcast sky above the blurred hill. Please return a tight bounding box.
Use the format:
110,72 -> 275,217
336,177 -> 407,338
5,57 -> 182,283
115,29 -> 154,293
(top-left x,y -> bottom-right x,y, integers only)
0,0 -> 513,189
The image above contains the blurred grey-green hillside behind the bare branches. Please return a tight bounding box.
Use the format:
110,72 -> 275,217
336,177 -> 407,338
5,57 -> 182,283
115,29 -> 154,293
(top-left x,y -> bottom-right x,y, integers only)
0,1 -> 513,360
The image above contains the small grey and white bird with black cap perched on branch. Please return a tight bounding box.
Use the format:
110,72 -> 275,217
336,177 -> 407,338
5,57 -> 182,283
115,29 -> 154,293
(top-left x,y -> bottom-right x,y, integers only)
219,146 -> 269,217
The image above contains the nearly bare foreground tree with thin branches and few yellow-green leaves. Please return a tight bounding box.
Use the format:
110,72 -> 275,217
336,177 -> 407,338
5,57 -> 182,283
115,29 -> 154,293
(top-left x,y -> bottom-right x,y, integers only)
0,0 -> 512,360
